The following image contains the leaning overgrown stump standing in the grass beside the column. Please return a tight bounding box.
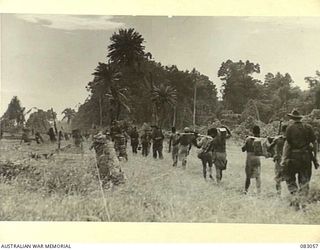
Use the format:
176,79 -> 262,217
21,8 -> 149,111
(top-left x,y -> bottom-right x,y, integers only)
90,132 -> 124,186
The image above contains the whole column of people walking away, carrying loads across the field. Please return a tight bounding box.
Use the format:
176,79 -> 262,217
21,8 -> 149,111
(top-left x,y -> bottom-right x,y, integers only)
89,110 -> 319,209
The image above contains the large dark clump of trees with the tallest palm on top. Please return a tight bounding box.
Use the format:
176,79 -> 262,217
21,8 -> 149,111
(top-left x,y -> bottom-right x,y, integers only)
72,29 -> 218,129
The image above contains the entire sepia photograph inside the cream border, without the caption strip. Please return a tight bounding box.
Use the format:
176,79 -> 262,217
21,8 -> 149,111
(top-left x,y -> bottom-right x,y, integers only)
0,13 -> 320,225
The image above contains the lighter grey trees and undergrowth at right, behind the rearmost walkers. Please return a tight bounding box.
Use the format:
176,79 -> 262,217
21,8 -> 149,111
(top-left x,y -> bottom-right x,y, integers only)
218,60 -> 320,123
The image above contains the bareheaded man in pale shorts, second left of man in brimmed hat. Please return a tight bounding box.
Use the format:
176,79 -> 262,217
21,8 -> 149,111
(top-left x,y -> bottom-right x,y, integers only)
242,126 -> 261,194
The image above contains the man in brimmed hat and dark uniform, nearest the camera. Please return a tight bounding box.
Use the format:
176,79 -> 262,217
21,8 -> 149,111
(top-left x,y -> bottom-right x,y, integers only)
282,109 -> 318,206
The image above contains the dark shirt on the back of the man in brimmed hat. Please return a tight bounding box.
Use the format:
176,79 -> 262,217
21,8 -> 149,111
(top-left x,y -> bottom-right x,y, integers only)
286,121 -> 316,149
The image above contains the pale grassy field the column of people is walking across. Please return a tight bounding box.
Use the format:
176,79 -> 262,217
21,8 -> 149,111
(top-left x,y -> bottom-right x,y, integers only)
0,140 -> 320,224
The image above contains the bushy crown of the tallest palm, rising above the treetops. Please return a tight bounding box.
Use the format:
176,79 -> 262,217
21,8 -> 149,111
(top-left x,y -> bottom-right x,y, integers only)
108,28 -> 151,66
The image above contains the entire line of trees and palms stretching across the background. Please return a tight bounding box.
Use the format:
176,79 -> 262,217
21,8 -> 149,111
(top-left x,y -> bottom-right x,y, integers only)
1,28 -> 320,131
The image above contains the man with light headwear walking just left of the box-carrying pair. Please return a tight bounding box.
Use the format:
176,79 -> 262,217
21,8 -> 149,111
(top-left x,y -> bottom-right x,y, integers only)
174,127 -> 195,169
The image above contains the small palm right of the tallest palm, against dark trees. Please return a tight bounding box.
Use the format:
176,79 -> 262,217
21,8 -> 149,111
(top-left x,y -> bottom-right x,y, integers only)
151,84 -> 177,127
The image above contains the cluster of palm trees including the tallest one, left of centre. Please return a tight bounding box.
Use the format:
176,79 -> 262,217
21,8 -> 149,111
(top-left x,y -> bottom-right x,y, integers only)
87,28 -> 177,126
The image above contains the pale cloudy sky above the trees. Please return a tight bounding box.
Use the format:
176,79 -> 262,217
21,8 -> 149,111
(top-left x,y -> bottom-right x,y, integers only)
0,14 -> 320,117
